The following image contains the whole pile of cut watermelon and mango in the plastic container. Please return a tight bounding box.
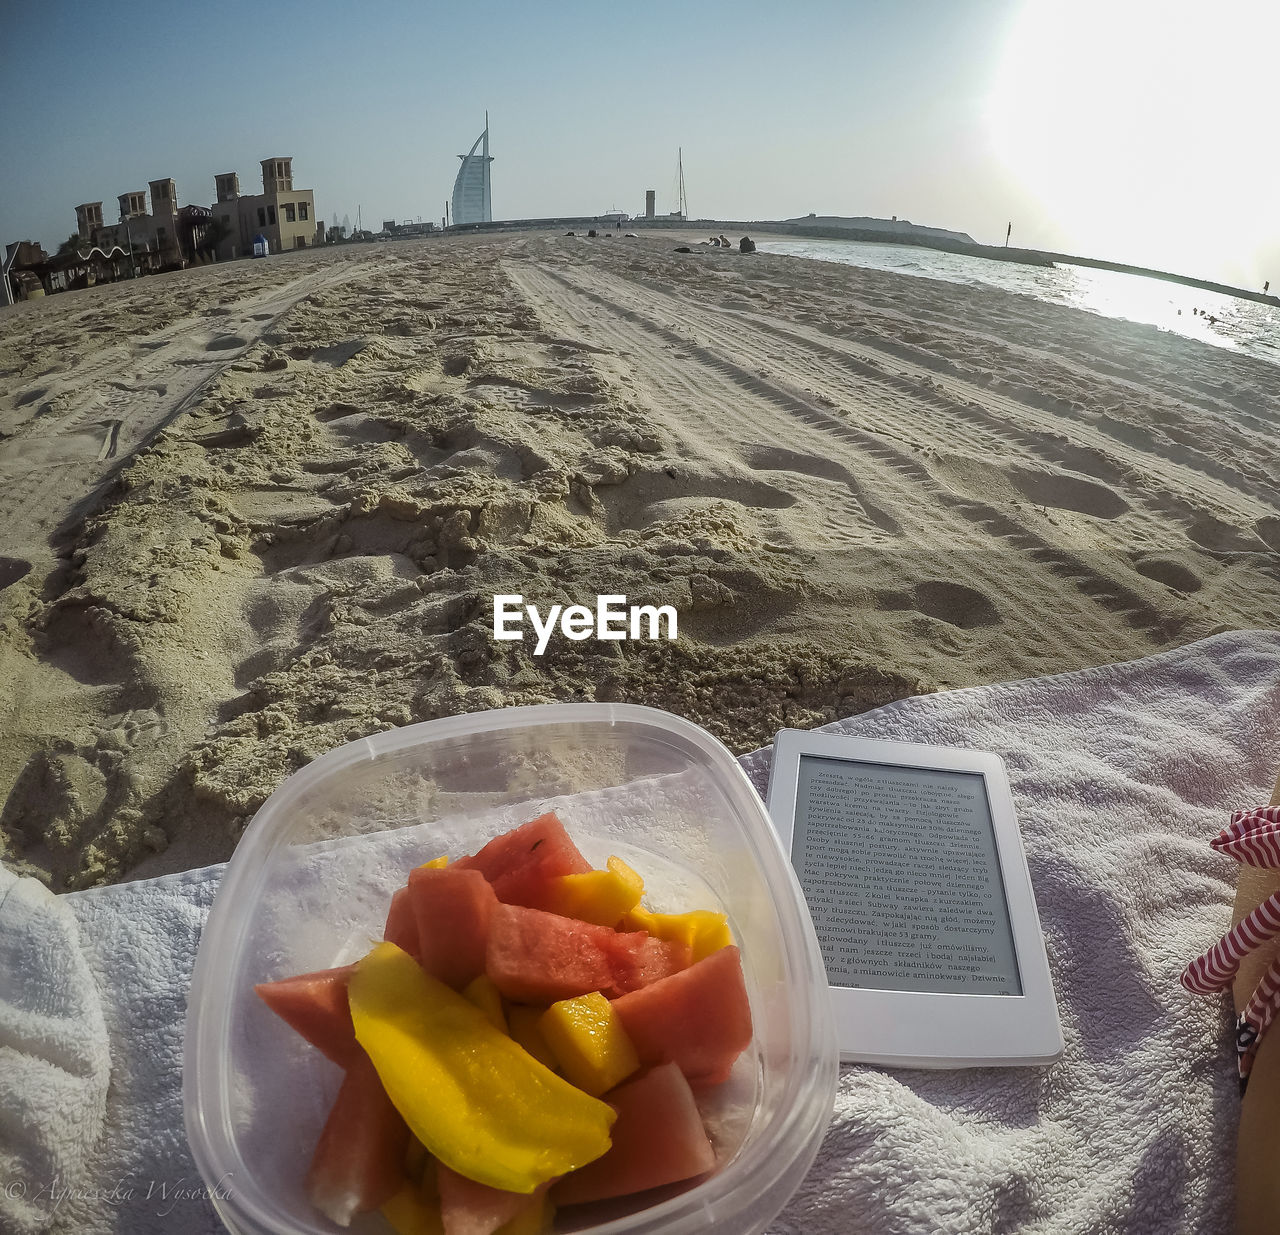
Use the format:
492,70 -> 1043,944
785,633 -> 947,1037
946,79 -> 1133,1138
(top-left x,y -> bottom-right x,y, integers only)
255,814 -> 753,1235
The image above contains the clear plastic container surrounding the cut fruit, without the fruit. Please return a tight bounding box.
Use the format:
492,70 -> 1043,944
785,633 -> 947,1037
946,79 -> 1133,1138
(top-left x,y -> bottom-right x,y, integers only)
183,704 -> 838,1235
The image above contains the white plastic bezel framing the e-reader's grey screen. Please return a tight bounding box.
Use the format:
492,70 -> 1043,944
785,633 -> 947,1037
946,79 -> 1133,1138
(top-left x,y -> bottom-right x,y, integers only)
768,729 -> 1062,1067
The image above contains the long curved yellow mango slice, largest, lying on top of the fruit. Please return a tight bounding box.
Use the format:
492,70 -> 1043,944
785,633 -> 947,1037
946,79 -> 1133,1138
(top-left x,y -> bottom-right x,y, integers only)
348,943 -> 616,1193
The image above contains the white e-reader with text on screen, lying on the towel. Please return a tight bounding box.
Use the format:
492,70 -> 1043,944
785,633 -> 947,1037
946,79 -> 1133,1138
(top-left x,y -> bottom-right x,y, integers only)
768,729 -> 1062,1067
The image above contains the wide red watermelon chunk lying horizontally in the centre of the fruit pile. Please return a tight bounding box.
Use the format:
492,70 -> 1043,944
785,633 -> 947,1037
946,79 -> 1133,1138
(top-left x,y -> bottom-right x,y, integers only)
485,905 -> 649,1003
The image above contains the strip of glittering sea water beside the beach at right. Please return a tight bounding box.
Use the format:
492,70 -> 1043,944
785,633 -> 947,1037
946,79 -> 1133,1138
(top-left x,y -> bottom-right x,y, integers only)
756,238 -> 1280,365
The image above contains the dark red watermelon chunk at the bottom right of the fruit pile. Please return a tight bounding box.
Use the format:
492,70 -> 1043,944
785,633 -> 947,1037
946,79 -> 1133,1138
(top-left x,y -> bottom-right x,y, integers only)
552,1064 -> 716,1206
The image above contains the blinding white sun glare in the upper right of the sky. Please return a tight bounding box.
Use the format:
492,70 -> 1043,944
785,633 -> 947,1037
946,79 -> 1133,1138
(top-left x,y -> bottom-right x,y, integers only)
988,0 -> 1280,278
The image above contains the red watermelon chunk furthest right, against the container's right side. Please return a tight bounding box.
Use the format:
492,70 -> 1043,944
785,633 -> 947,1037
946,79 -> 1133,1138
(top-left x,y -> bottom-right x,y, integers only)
613,944 -> 751,1085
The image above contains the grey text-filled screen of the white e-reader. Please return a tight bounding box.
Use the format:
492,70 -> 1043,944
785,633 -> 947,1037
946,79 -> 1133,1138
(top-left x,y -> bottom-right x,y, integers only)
791,754 -> 1023,996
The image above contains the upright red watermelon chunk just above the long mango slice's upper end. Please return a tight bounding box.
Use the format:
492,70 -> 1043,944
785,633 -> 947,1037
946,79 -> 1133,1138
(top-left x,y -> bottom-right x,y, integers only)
407,866 -> 498,991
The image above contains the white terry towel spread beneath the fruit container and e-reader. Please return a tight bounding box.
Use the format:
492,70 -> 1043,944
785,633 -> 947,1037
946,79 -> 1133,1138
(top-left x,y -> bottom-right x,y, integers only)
0,631 -> 1280,1235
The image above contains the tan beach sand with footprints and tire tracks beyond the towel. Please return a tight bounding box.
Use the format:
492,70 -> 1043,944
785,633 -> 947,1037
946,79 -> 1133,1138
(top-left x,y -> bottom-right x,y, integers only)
0,233 -> 1280,889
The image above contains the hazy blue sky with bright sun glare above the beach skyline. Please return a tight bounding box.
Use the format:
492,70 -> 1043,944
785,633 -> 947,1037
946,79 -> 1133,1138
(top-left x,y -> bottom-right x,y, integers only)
0,0 -> 1280,287
